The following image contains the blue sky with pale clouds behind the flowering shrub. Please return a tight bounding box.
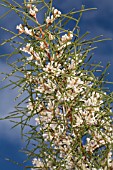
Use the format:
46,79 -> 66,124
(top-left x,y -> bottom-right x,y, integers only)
0,0 -> 113,170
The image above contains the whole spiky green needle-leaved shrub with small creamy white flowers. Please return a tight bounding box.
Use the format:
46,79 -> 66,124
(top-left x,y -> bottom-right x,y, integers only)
0,0 -> 113,170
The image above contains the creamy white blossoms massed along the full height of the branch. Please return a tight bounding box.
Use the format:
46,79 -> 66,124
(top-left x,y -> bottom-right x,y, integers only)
17,3 -> 113,170
